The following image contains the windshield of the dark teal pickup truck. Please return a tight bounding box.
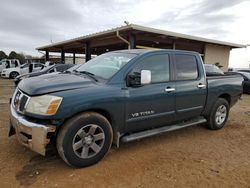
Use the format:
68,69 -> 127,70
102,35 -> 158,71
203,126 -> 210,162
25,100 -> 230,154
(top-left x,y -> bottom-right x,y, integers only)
76,53 -> 136,79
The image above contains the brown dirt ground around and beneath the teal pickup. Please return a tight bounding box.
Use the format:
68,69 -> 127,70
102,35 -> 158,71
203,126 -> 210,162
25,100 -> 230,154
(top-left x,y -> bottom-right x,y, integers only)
0,79 -> 250,188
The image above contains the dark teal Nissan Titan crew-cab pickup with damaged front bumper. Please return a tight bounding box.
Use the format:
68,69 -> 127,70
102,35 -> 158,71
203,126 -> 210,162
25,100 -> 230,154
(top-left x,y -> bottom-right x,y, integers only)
9,49 -> 243,167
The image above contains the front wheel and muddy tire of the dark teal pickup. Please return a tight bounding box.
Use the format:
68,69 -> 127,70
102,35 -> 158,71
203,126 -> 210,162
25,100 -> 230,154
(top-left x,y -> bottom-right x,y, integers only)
56,112 -> 113,167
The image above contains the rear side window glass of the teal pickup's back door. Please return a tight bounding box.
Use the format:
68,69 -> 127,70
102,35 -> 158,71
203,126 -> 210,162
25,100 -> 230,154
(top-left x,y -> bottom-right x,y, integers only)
175,54 -> 198,80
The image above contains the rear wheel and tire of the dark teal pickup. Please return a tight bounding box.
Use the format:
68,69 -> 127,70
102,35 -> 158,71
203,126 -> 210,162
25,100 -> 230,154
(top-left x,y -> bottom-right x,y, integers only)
207,98 -> 229,130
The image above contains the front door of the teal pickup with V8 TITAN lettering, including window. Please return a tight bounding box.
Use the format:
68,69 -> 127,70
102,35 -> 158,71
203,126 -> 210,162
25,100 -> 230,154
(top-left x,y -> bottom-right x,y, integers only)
126,53 -> 175,132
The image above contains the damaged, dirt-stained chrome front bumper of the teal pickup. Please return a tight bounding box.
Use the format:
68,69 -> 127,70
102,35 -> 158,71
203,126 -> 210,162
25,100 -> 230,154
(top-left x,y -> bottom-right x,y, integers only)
9,104 -> 56,156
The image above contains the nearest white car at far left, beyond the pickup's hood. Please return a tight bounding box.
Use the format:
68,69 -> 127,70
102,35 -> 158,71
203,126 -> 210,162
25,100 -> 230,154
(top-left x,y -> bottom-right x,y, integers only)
1,63 -> 45,79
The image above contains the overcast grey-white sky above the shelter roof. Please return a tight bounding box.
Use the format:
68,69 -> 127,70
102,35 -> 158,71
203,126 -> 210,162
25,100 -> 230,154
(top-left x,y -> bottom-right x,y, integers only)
0,0 -> 250,68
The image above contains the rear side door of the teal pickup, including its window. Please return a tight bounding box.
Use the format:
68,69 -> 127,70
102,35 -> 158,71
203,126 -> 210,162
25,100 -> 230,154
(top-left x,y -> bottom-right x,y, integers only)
173,53 -> 207,121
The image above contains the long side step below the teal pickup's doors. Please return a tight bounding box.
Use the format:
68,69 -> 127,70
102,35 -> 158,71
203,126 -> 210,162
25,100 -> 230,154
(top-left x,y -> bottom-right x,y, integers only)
121,117 -> 207,142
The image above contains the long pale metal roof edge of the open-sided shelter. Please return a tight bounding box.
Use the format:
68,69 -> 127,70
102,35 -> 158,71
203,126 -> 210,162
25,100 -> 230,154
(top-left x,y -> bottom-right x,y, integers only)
36,24 -> 246,50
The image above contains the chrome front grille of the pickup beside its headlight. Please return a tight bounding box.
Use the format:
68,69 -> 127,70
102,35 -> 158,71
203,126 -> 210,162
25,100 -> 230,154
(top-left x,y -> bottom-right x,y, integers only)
13,90 -> 29,113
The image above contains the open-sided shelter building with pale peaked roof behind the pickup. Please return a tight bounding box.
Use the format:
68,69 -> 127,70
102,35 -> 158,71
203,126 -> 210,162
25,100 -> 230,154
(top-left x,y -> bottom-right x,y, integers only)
37,24 -> 246,71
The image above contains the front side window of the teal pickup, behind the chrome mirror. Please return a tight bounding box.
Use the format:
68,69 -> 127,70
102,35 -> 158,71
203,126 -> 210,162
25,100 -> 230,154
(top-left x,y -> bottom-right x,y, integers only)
132,54 -> 170,83
